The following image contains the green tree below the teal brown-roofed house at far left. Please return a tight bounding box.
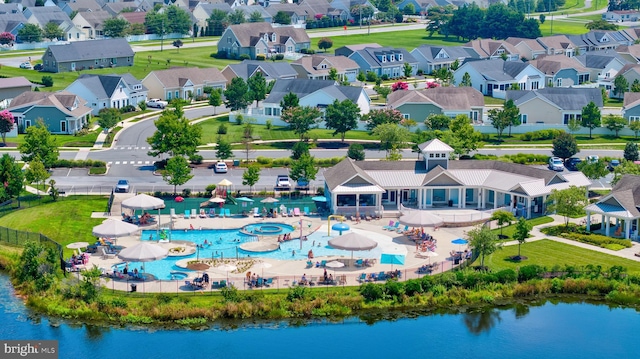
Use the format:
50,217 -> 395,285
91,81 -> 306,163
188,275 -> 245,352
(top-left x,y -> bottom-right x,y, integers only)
18,119 -> 60,168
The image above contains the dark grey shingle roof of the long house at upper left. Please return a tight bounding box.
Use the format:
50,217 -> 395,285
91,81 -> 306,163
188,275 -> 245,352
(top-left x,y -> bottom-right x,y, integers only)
47,38 -> 134,62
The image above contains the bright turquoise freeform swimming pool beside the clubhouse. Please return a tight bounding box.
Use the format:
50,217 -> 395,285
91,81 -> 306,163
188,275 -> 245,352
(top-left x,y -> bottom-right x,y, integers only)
138,228 -> 404,280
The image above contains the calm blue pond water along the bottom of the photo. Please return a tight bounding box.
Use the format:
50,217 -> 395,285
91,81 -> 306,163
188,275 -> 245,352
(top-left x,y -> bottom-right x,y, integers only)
0,275 -> 640,359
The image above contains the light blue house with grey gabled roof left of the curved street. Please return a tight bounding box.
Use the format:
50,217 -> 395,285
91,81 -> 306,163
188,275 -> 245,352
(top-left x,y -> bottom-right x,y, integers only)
65,74 -> 147,115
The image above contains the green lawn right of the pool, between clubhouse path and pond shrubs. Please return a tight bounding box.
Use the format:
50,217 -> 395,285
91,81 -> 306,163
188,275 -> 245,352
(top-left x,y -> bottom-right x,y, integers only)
476,239 -> 640,273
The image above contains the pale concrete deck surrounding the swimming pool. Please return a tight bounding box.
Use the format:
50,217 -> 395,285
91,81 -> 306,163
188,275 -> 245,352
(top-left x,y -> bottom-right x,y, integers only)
88,215 -> 465,292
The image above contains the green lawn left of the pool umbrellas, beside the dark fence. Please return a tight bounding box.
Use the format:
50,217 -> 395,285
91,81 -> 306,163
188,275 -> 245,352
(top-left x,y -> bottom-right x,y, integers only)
0,196 -> 107,256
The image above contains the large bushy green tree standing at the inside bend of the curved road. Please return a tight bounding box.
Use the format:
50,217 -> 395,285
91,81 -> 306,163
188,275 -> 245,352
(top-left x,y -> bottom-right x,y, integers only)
147,110 -> 202,157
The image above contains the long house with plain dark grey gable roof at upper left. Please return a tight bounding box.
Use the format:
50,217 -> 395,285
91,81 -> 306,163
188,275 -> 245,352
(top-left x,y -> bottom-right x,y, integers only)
42,38 -> 135,72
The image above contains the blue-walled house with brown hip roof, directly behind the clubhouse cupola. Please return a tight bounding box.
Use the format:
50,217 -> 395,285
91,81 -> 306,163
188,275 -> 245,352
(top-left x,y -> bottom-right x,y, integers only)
387,87 -> 484,123
